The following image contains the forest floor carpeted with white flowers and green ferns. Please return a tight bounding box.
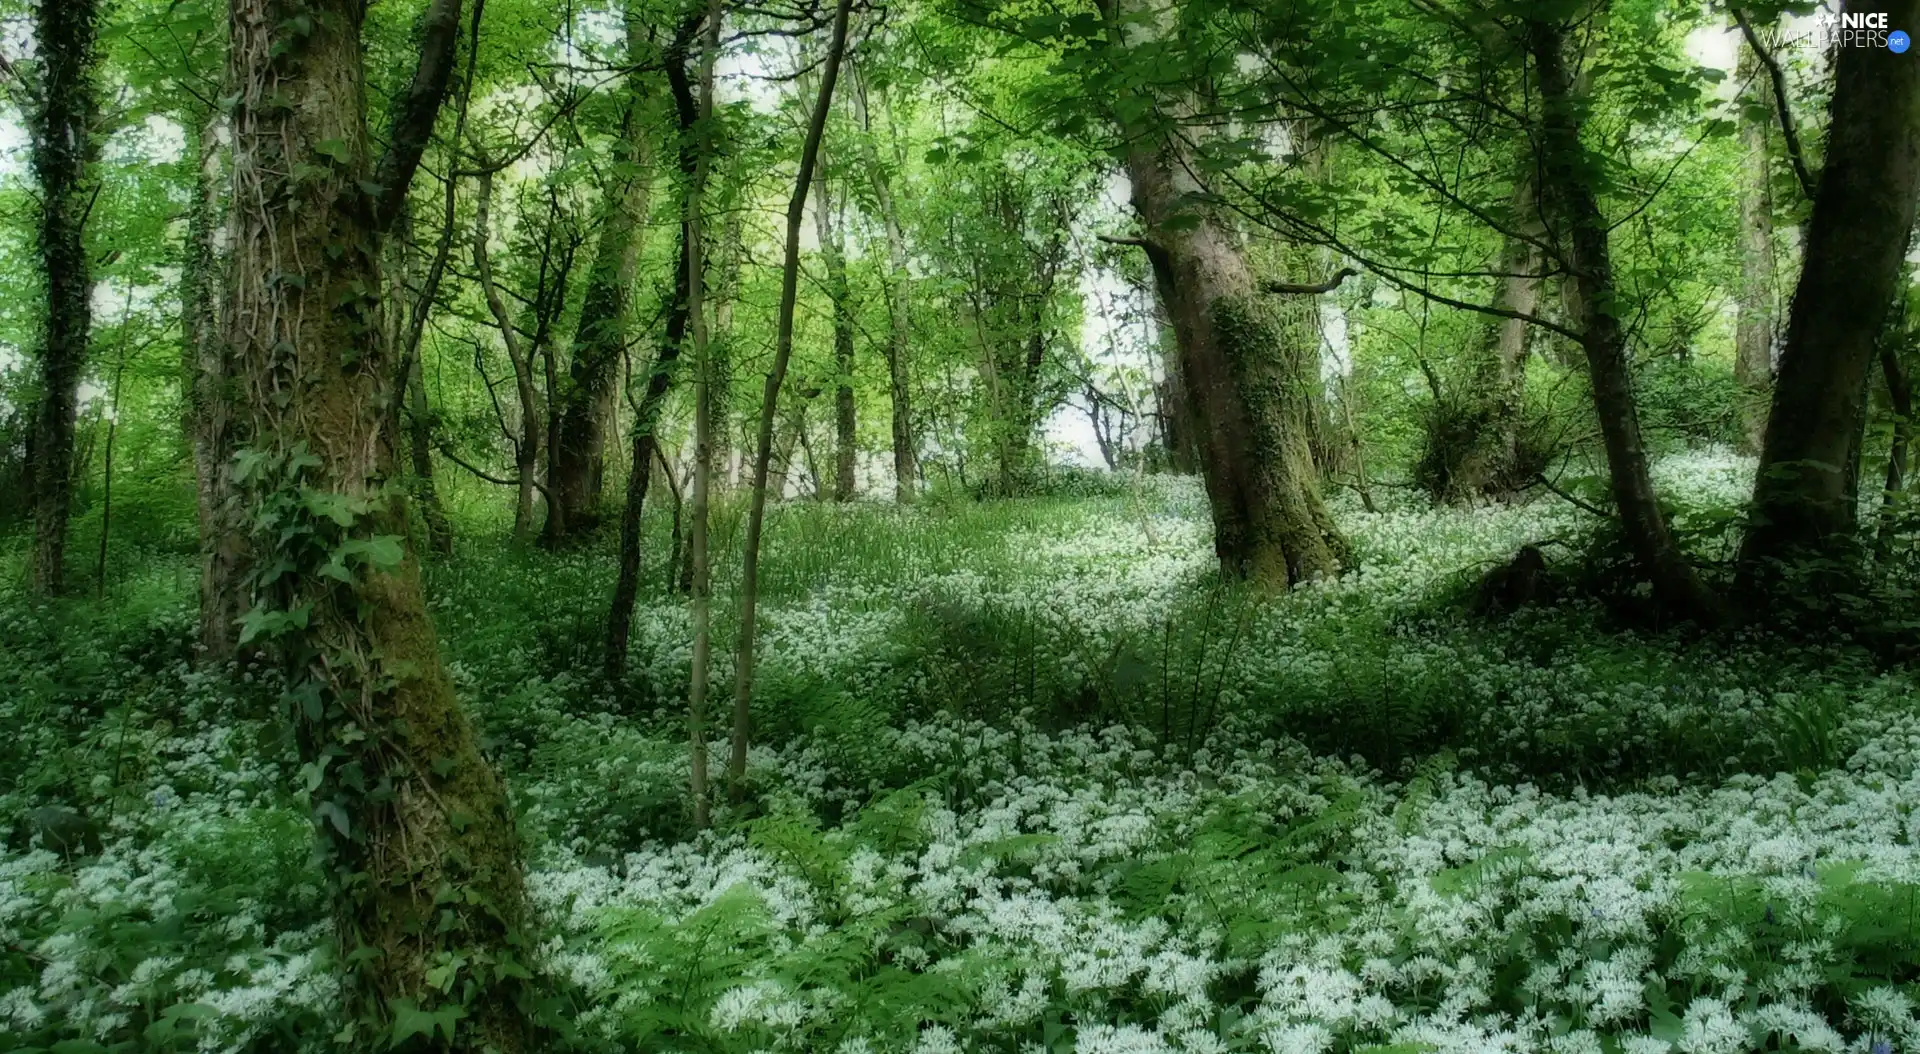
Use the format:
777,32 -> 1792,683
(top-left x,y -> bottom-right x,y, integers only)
0,453 -> 1920,1054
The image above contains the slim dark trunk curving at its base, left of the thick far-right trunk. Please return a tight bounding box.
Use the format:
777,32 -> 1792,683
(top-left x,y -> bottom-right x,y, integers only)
1526,21 -> 1720,622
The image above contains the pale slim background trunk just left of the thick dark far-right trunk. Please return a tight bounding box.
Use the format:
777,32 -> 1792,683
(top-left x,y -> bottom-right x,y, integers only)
1734,46 -> 1774,453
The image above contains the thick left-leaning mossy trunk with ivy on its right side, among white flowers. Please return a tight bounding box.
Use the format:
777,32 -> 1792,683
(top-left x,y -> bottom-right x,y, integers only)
1100,0 -> 1346,589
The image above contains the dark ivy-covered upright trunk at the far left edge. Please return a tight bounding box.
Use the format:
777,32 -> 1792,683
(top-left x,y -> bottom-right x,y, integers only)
27,0 -> 100,597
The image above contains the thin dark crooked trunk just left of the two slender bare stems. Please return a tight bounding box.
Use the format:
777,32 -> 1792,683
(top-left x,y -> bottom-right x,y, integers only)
605,15 -> 705,678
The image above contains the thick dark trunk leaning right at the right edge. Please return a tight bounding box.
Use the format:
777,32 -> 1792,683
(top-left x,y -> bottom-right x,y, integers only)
1738,0 -> 1920,595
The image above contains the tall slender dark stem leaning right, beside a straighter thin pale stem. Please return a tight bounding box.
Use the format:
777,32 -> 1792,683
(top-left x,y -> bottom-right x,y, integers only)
725,0 -> 852,801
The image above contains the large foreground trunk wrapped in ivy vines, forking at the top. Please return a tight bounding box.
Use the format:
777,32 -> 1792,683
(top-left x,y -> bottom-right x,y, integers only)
223,0 -> 534,1052
